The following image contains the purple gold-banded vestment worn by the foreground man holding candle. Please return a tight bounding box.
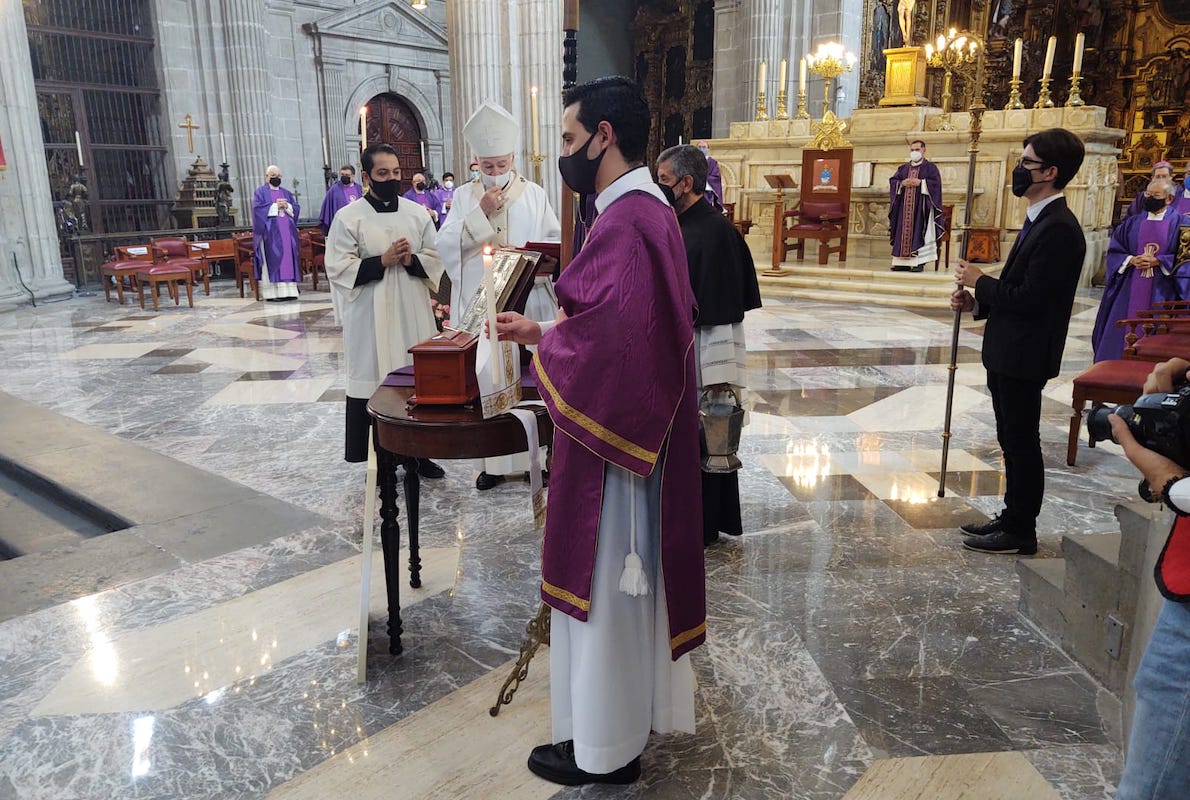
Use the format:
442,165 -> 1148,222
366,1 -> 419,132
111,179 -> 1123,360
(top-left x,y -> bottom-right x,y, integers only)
532,190 -> 707,660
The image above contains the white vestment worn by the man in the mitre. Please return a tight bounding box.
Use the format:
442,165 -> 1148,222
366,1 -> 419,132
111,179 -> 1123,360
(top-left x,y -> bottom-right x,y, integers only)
438,170 -> 562,475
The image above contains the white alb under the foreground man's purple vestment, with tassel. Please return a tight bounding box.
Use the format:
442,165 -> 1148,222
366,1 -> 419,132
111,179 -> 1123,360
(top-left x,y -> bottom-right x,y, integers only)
550,168 -> 694,774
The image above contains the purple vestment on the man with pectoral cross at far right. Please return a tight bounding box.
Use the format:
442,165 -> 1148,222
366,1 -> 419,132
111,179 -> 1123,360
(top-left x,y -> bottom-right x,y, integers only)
1091,206 -> 1180,361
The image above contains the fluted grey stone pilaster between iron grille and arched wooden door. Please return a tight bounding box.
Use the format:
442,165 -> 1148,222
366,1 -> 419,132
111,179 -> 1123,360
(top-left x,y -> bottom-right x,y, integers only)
220,0 -> 274,211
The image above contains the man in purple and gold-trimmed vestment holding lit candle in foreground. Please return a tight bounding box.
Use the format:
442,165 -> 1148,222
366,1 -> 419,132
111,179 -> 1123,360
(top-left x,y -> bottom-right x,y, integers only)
497,77 -> 707,786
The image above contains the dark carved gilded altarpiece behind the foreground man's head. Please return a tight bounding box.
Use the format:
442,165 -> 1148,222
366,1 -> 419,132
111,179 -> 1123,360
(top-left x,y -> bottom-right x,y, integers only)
632,0 -> 715,163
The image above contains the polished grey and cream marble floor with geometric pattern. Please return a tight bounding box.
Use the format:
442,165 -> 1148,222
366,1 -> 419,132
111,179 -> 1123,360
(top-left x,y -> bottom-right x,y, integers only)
0,282 -> 1135,800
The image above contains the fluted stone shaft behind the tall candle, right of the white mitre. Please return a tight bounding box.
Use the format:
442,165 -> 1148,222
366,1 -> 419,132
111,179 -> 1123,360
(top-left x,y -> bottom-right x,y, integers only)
513,0 -> 562,204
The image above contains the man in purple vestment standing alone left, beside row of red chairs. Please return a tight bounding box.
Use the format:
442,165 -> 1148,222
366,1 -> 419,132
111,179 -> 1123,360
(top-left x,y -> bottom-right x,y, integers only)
252,164 -> 301,300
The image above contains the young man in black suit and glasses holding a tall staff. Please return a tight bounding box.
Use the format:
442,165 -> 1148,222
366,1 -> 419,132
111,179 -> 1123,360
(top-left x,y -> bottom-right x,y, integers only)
951,127 -> 1086,555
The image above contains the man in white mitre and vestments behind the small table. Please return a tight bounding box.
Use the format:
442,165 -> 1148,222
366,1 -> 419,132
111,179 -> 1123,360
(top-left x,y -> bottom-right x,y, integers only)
438,102 -> 562,489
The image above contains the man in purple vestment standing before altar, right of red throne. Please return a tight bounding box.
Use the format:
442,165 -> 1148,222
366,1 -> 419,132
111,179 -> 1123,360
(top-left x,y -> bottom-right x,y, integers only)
889,139 -> 944,273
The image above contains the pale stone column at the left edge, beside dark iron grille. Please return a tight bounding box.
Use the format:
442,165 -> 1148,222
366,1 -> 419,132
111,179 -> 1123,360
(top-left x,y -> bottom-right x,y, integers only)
0,2 -> 74,308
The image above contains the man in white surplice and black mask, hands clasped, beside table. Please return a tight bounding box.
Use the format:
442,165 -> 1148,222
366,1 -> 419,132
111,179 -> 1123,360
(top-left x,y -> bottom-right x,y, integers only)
326,144 -> 443,477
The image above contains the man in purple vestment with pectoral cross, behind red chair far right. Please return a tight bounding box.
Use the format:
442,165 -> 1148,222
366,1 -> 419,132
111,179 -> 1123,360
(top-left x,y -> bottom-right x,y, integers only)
1091,179 -> 1190,361
